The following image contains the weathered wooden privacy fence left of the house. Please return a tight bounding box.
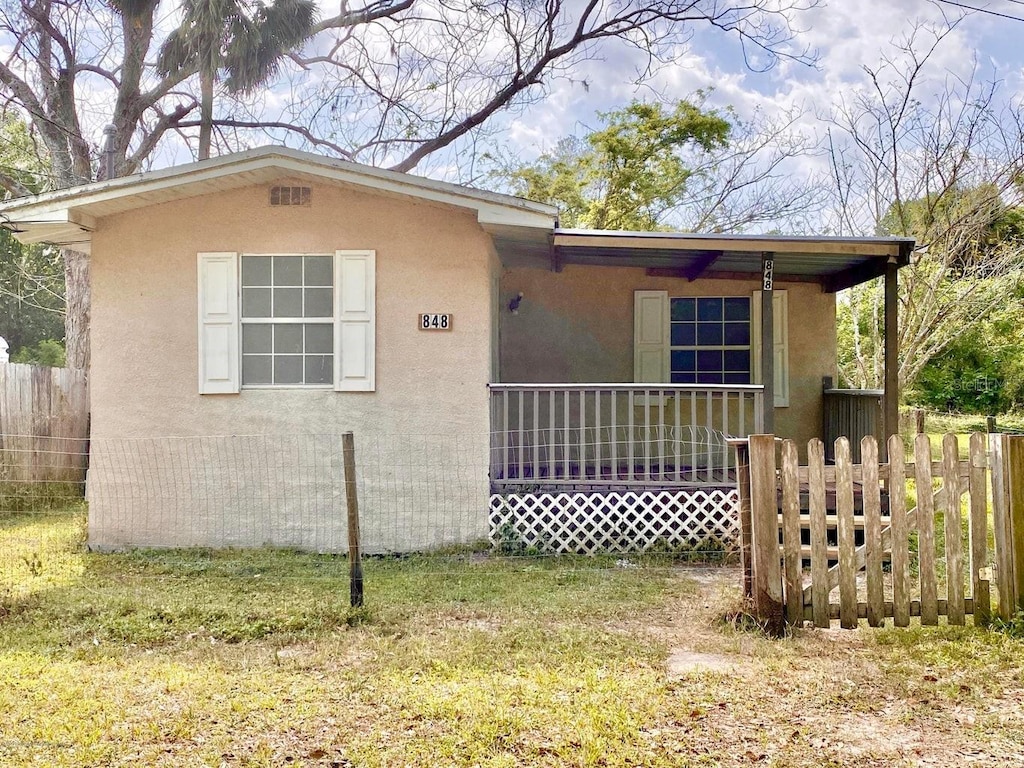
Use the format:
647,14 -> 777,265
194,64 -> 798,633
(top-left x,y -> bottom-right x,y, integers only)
0,362 -> 89,482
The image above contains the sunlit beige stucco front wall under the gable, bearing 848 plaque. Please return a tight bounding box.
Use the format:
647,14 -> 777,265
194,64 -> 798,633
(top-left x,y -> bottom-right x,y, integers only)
89,181 -> 494,550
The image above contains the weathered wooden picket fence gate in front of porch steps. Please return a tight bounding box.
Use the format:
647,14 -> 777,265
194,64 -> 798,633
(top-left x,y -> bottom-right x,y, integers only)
737,434 -> 1024,631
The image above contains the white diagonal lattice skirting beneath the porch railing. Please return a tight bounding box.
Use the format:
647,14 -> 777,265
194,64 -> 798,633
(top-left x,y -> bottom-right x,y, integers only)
489,489 -> 739,554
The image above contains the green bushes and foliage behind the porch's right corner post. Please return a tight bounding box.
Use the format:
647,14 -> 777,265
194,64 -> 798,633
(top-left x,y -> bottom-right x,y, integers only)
838,183 -> 1024,393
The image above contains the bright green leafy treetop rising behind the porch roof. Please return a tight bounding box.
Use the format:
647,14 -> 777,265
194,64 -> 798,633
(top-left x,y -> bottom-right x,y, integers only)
501,94 -> 730,229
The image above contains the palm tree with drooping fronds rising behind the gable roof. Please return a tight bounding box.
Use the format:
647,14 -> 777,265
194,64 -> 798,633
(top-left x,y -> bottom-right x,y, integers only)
157,0 -> 316,160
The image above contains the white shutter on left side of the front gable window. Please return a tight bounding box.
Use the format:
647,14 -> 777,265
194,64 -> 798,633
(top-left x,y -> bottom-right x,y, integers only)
198,252 -> 239,394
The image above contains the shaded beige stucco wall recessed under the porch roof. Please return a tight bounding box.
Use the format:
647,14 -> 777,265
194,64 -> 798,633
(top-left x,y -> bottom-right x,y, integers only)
500,265 -> 836,441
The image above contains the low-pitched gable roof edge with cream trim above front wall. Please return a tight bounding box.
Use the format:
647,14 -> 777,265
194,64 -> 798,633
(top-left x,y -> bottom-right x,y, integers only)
0,146 -> 557,252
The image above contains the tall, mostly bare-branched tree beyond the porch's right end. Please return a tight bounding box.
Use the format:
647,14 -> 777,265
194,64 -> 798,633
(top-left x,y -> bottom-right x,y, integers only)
828,25 -> 1024,392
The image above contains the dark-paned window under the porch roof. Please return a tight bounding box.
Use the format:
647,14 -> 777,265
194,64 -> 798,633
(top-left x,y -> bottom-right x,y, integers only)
669,296 -> 751,384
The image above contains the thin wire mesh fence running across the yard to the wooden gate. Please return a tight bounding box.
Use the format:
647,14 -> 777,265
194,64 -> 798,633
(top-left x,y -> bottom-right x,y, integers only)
0,434 -> 738,612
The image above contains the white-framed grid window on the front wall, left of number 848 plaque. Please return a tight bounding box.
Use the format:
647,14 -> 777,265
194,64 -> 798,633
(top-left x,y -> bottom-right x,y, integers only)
242,255 -> 334,387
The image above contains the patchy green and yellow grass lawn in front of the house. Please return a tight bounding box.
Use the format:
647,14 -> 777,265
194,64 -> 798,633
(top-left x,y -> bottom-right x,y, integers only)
0,515 -> 1024,767
